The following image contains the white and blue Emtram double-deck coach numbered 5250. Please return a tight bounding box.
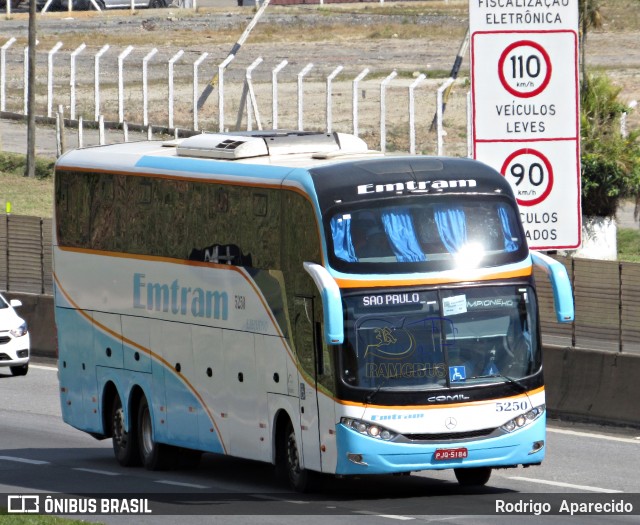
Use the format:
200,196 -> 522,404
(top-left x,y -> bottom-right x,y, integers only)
54,131 -> 573,490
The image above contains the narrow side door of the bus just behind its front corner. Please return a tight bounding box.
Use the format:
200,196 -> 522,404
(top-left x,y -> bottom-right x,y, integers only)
293,295 -> 322,471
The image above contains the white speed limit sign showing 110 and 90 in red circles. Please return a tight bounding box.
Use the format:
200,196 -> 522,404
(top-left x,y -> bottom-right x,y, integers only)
469,0 -> 581,250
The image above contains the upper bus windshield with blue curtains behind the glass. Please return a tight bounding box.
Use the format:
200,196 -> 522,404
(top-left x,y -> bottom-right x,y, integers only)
328,195 -> 527,273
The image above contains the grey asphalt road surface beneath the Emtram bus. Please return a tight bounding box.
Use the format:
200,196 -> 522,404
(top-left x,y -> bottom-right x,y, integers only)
0,363 -> 640,525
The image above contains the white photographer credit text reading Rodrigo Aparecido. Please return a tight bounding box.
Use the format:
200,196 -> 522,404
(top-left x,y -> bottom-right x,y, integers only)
495,495 -> 635,516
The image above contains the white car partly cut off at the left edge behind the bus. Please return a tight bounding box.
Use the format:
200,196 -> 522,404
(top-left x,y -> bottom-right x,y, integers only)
0,294 -> 30,376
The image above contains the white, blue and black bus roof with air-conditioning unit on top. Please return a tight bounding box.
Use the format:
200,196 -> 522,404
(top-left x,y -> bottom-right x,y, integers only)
57,130 -> 512,204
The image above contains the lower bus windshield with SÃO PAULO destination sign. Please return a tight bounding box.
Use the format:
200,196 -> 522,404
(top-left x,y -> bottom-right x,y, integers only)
341,285 -> 541,390
